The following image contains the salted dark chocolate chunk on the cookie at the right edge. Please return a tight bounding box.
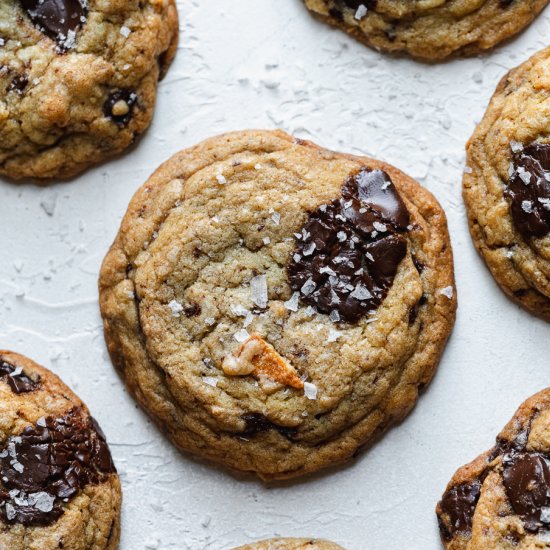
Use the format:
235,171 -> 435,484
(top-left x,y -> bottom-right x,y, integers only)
505,143 -> 550,238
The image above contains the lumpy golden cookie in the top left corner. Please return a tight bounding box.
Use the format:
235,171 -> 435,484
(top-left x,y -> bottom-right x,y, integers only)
0,0 -> 178,179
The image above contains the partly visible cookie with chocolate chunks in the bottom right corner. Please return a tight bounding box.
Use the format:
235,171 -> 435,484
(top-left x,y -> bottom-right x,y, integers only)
437,389 -> 550,550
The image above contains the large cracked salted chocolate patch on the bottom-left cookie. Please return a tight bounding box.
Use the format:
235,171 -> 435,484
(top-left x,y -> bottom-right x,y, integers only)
0,409 -> 116,526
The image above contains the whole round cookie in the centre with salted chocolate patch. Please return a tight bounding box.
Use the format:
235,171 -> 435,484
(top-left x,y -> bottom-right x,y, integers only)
99,131 -> 456,479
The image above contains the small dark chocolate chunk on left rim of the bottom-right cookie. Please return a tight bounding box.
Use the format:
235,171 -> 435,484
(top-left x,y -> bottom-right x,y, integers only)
438,481 -> 481,540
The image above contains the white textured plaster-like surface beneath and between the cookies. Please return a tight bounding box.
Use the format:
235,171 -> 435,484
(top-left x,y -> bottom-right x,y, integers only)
0,0 -> 550,550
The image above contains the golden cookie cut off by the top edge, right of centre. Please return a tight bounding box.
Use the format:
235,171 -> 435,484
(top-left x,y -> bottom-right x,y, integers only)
304,0 -> 548,60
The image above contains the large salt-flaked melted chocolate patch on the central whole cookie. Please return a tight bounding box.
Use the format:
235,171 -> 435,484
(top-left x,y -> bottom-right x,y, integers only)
287,168 -> 409,323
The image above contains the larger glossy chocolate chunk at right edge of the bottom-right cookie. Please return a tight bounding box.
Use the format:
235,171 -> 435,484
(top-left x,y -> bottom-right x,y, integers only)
502,453 -> 550,532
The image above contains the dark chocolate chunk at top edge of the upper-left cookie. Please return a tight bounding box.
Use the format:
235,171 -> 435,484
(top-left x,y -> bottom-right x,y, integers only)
20,0 -> 88,49
